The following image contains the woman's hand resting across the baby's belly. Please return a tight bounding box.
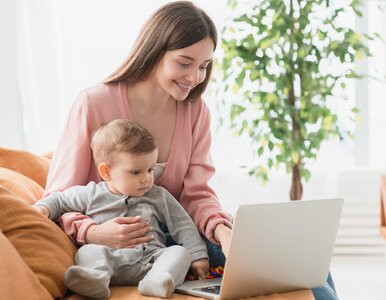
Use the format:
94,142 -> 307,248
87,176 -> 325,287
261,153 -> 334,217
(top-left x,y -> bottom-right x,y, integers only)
86,216 -> 154,249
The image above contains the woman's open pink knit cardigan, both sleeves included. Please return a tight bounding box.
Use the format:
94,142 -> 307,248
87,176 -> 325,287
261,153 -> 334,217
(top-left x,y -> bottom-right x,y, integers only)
45,83 -> 232,243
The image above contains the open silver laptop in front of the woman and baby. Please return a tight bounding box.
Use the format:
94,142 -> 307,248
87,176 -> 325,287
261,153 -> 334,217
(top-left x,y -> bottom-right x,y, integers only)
176,199 -> 343,299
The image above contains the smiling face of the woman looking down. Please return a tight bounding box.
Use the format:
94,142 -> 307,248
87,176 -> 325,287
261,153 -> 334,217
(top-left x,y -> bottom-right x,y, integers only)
154,37 -> 214,100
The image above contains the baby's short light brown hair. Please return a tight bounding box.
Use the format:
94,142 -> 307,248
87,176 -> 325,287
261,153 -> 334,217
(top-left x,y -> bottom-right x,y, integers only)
91,119 -> 157,166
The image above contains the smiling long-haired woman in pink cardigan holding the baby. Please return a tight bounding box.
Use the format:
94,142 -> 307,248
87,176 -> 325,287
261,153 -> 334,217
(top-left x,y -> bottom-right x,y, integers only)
46,1 -> 334,299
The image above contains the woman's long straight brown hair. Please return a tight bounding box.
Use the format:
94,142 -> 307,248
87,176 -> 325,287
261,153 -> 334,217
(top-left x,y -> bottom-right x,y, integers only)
104,1 -> 217,101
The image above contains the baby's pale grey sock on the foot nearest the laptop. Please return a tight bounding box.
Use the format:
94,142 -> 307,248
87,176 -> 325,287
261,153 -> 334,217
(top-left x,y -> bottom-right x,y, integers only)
138,272 -> 175,298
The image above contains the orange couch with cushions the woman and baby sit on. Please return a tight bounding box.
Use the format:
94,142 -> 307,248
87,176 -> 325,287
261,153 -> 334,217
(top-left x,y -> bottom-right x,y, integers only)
0,148 -> 314,300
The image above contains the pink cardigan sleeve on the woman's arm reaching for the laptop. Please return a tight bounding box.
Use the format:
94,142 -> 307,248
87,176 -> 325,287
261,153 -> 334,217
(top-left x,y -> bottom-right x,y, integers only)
180,103 -> 232,243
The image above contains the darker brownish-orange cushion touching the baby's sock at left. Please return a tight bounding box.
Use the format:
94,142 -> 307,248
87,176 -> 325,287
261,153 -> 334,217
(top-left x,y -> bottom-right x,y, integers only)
0,186 -> 76,299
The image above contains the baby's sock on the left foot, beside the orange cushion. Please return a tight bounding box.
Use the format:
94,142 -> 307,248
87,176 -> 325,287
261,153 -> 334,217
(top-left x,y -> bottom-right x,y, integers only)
64,266 -> 110,299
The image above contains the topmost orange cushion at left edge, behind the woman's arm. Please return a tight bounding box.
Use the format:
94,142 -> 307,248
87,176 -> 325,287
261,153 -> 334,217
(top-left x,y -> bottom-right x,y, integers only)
0,148 -> 50,189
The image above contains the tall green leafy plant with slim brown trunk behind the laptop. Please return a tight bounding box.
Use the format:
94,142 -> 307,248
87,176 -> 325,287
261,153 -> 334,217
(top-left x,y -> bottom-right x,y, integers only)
216,0 -> 377,200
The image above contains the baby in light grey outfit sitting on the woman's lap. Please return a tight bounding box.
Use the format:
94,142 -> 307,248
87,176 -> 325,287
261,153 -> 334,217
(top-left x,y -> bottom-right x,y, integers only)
34,119 -> 209,299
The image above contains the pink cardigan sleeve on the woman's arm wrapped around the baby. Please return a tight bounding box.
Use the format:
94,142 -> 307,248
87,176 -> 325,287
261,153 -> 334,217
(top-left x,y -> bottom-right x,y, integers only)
44,92 -> 96,243
